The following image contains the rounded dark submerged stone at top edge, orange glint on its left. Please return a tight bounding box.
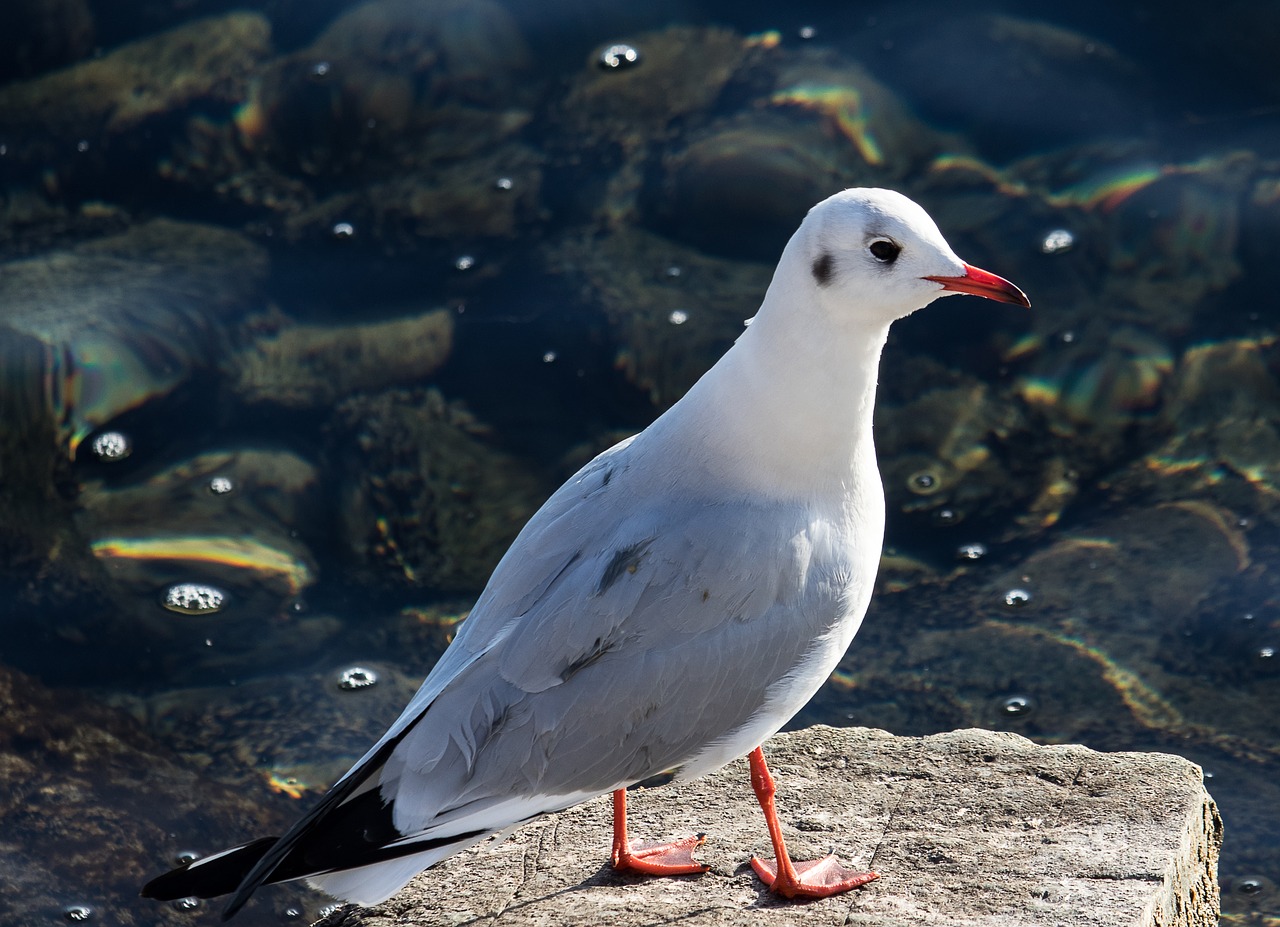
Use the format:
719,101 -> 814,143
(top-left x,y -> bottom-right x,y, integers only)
244,0 -> 530,183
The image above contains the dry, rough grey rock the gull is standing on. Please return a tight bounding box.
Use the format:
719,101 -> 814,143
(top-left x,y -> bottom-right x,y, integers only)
309,727 -> 1222,927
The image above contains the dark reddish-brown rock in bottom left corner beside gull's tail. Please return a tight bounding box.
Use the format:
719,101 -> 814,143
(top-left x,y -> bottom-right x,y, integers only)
0,667 -> 298,927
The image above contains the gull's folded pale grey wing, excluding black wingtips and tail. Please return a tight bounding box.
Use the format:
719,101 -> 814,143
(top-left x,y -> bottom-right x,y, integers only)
379,458 -> 849,834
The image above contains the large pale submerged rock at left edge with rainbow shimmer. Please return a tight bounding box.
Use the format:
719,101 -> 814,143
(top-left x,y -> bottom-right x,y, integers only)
0,219 -> 266,457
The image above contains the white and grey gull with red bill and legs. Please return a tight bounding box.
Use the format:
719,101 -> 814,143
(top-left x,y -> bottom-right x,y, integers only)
142,188 -> 1030,919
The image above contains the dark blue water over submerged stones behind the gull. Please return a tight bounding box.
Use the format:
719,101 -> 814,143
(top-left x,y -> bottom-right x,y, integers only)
0,0 -> 1280,924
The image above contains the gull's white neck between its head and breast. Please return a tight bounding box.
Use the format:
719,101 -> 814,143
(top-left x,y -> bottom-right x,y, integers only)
653,294 -> 888,504
